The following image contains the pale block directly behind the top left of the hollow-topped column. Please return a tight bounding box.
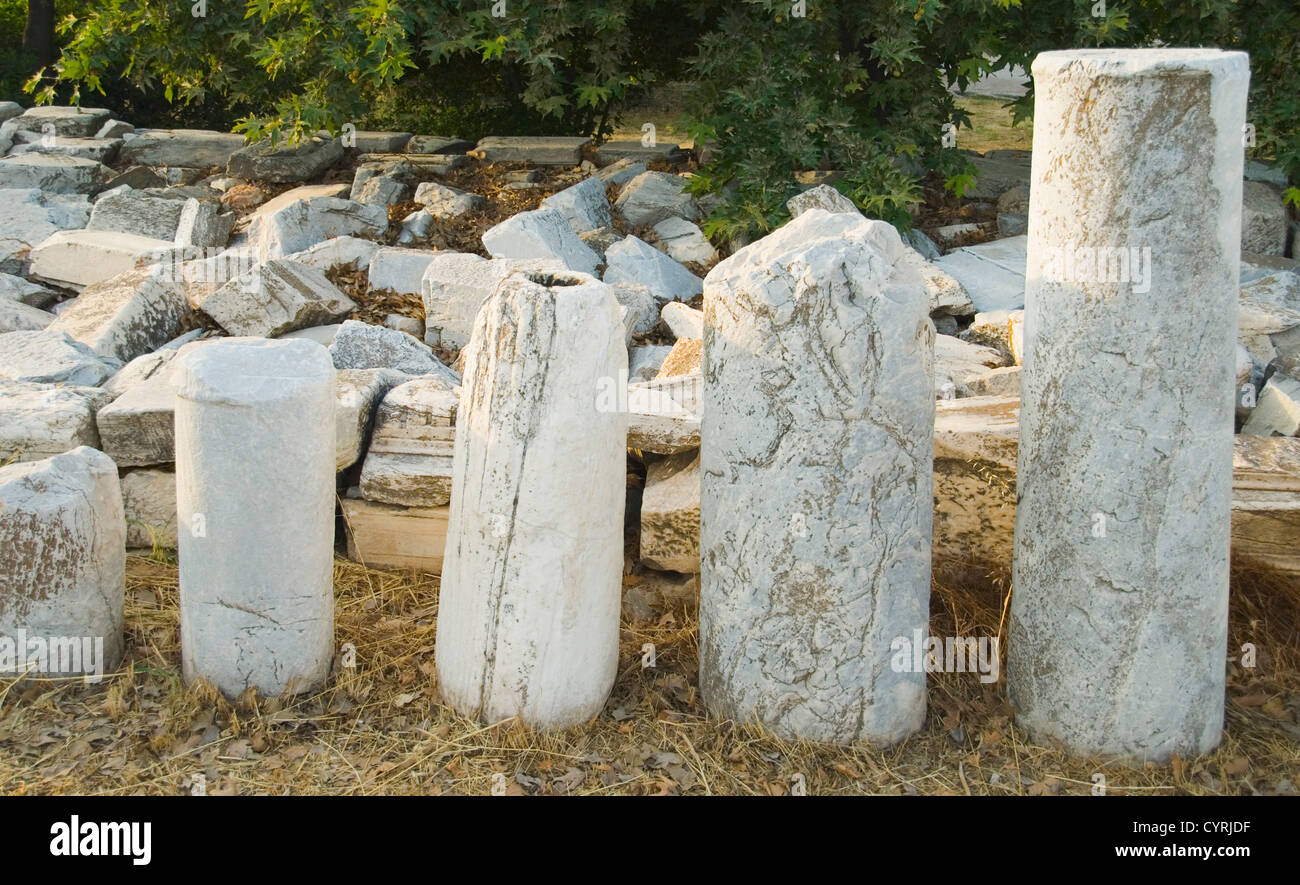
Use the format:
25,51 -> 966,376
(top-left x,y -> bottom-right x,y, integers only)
420,252 -> 564,347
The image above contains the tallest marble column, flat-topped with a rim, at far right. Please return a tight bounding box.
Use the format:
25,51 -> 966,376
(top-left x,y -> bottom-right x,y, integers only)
1008,49 -> 1249,759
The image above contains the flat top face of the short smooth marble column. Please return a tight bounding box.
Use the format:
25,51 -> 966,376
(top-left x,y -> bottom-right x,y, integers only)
172,338 -> 334,405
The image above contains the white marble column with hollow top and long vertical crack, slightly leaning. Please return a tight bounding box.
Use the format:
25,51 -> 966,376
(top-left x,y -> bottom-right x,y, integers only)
437,272 -> 628,729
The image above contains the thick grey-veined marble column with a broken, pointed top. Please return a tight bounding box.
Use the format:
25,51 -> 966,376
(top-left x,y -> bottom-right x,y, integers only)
699,209 -> 935,743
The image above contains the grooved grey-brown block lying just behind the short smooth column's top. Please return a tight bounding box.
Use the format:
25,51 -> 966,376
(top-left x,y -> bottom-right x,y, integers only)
199,259 -> 364,337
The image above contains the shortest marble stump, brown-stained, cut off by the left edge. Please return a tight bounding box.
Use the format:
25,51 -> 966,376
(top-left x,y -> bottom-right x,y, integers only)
0,447 -> 126,677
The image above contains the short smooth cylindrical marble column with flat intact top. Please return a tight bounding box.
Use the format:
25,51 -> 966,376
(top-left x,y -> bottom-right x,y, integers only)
173,338 -> 334,698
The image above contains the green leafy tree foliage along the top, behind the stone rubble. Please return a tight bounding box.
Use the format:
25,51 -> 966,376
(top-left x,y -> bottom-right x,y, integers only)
30,0 -> 1300,232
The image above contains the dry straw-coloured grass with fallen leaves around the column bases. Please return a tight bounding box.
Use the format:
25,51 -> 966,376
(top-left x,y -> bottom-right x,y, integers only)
0,556 -> 1300,795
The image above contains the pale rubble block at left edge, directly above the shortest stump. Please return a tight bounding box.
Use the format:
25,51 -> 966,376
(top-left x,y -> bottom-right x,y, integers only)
0,381 -> 113,463
